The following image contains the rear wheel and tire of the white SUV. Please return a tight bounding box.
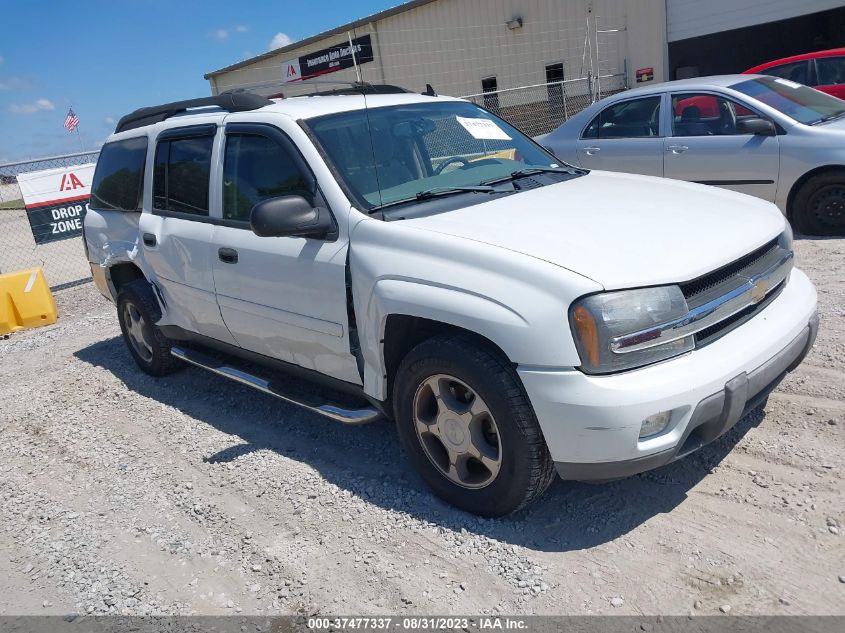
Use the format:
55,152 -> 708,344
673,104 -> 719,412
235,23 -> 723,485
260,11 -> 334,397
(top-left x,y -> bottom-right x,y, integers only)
117,279 -> 183,376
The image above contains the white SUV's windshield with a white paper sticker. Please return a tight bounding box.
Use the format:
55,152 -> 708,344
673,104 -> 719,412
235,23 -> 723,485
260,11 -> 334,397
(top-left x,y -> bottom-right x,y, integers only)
308,101 -> 559,210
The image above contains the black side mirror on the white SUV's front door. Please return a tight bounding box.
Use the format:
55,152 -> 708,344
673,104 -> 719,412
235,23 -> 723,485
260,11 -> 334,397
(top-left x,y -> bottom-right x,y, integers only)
249,196 -> 333,238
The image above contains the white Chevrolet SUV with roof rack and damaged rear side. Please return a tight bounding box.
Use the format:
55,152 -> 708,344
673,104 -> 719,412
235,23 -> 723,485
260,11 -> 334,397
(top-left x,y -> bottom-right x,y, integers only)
84,87 -> 817,516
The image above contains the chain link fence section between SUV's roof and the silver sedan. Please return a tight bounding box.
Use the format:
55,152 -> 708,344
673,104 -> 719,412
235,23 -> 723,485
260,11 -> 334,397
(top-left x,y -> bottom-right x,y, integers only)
463,74 -> 626,137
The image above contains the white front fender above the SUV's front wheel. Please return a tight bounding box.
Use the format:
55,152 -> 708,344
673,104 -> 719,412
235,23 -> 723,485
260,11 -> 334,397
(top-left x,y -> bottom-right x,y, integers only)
350,221 -> 601,400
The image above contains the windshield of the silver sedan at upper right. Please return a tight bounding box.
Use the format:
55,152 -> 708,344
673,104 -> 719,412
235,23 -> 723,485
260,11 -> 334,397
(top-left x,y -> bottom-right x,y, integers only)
731,77 -> 845,125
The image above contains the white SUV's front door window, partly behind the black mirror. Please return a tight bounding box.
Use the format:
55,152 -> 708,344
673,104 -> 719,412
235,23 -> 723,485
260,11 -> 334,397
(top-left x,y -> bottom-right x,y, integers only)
223,134 -> 313,222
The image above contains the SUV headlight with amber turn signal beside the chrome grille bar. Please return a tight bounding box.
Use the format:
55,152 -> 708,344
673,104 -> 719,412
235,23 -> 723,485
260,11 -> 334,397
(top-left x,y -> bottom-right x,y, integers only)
569,286 -> 695,374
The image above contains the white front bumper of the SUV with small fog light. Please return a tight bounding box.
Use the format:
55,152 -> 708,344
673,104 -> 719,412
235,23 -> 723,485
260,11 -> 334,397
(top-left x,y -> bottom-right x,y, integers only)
519,270 -> 818,480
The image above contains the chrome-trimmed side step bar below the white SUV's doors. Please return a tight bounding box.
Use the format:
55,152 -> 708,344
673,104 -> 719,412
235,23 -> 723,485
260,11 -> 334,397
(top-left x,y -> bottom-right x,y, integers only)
170,347 -> 381,424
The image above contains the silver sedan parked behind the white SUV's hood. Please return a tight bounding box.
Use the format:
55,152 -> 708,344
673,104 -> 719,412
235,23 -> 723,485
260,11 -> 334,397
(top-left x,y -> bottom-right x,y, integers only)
537,75 -> 845,235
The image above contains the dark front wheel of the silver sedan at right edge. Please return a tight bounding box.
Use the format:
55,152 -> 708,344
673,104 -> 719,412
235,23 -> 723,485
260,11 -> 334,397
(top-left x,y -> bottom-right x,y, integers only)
792,171 -> 845,236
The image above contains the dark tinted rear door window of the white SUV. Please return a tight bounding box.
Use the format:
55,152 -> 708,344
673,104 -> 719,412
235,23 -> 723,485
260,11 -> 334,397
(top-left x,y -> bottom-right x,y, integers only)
153,136 -> 214,216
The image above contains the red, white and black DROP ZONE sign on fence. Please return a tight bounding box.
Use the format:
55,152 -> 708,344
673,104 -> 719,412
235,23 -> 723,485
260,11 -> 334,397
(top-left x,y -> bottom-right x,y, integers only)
18,163 -> 95,244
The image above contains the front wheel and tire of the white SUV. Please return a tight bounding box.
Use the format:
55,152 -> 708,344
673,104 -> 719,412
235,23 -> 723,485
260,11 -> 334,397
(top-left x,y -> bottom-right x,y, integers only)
393,334 -> 555,517
